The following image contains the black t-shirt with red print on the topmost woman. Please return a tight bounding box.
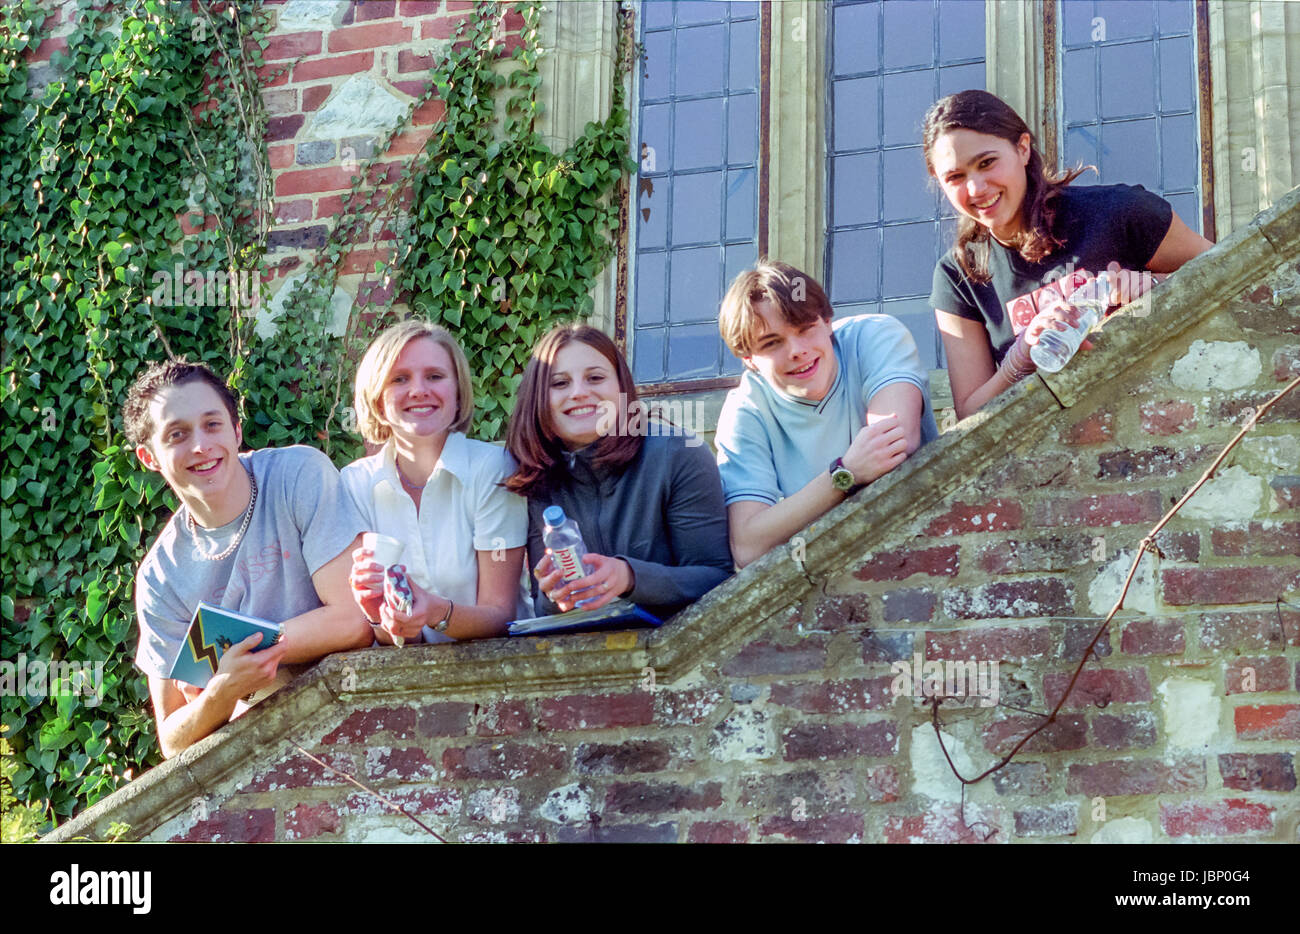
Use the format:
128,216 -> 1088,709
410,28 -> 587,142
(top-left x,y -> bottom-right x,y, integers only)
930,185 -> 1174,363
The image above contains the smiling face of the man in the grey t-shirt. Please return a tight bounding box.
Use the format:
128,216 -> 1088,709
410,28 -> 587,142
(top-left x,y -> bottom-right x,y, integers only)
135,380 -> 247,510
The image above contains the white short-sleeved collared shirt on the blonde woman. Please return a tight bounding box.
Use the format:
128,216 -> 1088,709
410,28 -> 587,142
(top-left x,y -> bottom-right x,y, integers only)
341,432 -> 532,643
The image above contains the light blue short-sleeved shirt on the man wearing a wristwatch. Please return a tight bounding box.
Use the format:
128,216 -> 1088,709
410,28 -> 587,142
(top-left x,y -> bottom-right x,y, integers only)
715,315 -> 939,506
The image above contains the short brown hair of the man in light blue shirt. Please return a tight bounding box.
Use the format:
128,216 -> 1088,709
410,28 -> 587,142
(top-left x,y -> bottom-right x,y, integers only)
718,256 -> 835,356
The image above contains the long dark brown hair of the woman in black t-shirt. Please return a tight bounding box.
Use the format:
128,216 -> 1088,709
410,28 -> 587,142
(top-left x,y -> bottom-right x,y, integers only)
922,90 -> 1084,282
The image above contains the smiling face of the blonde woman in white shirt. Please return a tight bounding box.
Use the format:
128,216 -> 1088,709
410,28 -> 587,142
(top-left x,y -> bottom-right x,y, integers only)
377,337 -> 458,441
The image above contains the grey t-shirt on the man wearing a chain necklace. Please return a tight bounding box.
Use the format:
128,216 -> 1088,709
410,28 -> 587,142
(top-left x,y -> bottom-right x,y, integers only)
135,445 -> 365,678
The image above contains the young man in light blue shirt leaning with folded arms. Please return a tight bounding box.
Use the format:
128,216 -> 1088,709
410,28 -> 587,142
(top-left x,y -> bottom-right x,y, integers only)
716,260 -> 939,567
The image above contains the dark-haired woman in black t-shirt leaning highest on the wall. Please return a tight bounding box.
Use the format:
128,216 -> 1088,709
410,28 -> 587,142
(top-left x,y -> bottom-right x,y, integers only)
923,91 -> 1212,418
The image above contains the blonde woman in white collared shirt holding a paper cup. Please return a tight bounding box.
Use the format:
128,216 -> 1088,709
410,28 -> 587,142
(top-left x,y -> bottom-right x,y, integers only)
342,319 -> 532,645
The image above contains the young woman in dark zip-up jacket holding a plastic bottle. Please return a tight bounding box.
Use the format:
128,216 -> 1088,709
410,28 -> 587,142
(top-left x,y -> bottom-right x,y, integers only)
506,325 -> 732,618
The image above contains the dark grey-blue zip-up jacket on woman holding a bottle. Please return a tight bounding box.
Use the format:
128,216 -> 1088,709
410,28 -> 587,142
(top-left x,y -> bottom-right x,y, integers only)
528,434 -> 736,619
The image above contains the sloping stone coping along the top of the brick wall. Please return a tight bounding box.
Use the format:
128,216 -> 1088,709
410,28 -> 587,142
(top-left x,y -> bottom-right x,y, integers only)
44,189 -> 1300,840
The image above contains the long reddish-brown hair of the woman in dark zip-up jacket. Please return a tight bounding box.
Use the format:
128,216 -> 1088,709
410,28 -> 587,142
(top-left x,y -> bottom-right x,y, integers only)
504,324 -> 641,496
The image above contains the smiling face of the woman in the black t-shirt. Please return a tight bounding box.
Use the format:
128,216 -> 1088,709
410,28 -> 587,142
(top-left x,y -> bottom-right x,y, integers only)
930,130 -> 1031,243
